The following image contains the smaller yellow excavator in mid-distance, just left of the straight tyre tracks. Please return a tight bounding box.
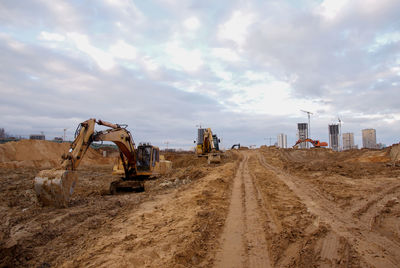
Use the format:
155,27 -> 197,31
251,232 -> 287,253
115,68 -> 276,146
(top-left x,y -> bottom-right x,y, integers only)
195,128 -> 221,164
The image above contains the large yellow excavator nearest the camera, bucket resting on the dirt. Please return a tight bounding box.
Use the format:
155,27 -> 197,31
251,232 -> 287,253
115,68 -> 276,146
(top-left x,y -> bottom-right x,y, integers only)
34,118 -> 160,207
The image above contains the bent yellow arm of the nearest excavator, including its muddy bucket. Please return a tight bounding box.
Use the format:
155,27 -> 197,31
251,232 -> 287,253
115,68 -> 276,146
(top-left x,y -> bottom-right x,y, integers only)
34,119 -> 137,207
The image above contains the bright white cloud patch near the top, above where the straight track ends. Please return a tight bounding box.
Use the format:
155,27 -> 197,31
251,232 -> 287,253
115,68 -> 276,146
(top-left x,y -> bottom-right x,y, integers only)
218,11 -> 254,46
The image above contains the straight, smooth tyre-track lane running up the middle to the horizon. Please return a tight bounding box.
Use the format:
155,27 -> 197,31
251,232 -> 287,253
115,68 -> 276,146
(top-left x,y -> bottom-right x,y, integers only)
214,153 -> 271,267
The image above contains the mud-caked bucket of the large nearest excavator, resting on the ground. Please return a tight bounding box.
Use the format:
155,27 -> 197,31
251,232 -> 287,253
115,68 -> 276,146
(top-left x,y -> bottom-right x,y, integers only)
34,169 -> 78,207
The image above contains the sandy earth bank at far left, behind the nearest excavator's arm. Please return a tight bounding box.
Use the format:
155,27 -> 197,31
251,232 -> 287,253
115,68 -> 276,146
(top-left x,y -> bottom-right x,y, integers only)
0,140 -> 112,168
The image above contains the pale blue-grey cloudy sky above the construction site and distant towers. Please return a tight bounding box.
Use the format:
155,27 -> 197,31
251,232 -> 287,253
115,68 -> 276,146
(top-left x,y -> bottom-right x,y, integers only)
0,0 -> 400,148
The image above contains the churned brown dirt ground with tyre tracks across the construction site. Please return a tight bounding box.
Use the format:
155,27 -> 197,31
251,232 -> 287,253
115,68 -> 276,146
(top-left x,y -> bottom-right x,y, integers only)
0,141 -> 400,267
